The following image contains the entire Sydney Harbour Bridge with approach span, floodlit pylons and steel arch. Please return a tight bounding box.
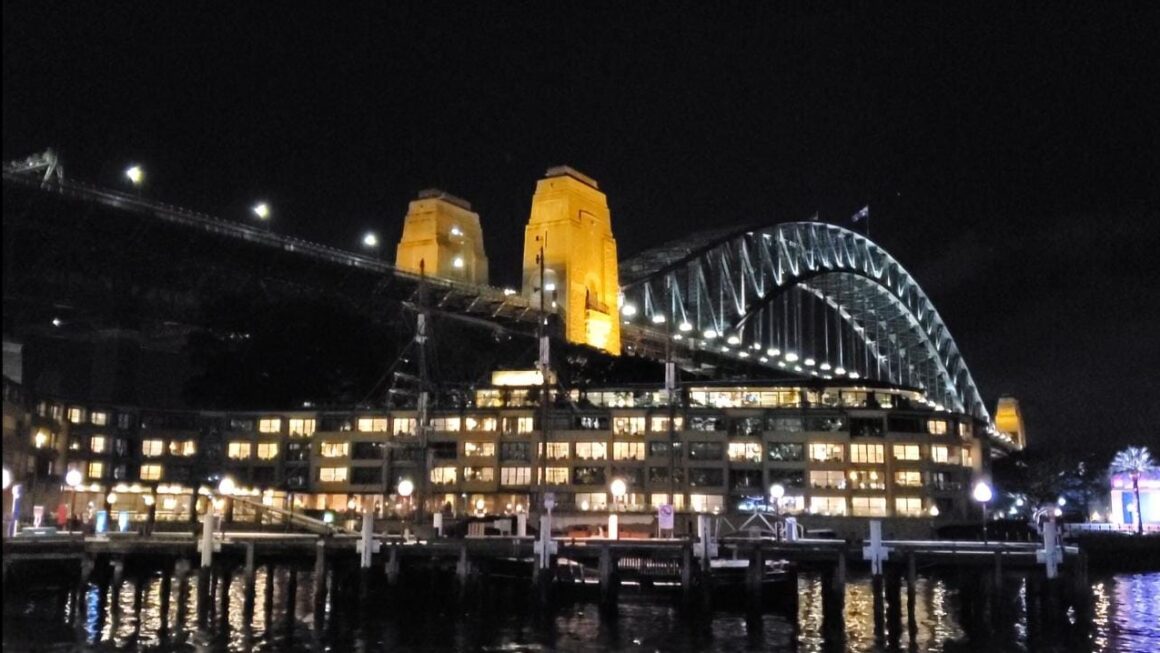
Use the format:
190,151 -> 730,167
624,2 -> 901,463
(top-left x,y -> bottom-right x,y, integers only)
3,157 -> 1013,447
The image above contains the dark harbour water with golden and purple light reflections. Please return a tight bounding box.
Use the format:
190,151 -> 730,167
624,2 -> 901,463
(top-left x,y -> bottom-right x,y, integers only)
3,567 -> 1160,653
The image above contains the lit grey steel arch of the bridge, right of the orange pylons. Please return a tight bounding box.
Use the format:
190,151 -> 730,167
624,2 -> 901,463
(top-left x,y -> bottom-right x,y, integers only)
619,222 -> 991,423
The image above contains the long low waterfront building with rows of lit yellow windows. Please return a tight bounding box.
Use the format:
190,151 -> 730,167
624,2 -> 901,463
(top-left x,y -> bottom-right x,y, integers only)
13,373 -> 991,521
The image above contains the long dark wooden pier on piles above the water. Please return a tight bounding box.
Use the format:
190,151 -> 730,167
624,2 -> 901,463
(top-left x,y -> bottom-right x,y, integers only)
3,524 -> 1089,640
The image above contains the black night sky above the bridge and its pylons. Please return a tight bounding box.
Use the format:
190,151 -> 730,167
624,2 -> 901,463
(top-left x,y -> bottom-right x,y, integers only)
3,2 -> 1160,448
